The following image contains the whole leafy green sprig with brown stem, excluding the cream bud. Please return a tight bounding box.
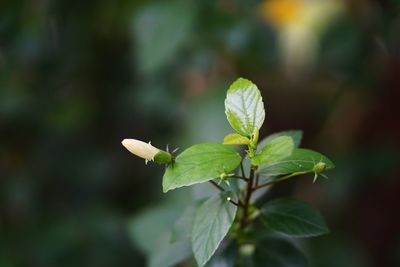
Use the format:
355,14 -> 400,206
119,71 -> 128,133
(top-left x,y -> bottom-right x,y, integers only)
129,78 -> 334,267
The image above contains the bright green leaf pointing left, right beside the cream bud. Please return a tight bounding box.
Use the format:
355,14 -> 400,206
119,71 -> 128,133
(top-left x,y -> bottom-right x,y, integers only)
163,143 -> 242,193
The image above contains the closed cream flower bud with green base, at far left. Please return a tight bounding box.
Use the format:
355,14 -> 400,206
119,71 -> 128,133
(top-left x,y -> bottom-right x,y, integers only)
122,139 -> 172,164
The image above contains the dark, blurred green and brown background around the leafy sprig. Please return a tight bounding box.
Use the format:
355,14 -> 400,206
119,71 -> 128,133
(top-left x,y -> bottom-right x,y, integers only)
0,0 -> 400,267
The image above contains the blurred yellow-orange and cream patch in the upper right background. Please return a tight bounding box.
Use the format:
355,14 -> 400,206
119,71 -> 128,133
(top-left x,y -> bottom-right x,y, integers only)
259,0 -> 345,77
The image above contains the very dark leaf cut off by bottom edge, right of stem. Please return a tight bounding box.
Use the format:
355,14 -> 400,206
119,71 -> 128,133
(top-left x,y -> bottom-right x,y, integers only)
253,238 -> 308,267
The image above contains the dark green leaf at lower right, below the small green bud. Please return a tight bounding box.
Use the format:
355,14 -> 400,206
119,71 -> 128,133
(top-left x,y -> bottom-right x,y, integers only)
261,199 -> 329,237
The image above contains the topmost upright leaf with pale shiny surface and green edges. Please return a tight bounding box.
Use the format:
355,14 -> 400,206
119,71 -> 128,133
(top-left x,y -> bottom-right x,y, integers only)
225,78 -> 265,137
